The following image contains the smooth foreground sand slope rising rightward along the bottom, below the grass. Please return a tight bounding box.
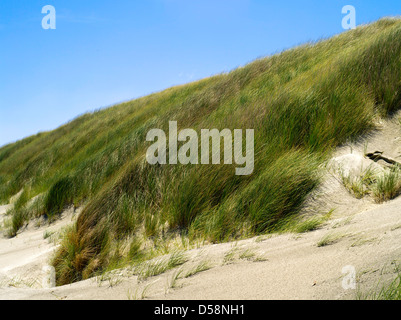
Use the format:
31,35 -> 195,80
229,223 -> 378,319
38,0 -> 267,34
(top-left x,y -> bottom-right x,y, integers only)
0,199 -> 401,299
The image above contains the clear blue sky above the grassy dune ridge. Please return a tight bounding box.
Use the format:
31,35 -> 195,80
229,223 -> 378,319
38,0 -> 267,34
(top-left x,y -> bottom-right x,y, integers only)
0,0 -> 401,146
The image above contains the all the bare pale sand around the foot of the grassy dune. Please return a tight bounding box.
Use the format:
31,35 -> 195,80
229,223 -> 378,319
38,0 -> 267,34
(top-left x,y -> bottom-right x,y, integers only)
0,115 -> 401,299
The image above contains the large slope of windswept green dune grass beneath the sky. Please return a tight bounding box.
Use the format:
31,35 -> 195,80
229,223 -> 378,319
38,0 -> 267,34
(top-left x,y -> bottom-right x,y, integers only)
0,19 -> 401,284
